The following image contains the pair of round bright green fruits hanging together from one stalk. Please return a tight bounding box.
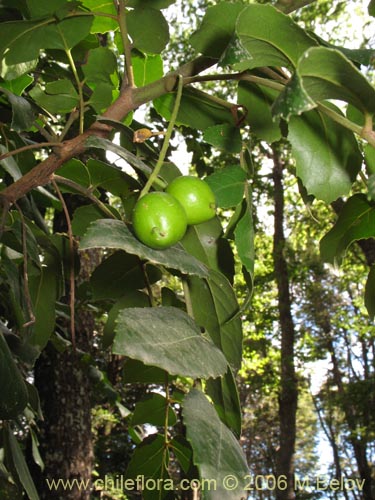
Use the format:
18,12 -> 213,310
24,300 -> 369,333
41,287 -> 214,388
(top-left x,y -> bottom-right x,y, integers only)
133,175 -> 216,249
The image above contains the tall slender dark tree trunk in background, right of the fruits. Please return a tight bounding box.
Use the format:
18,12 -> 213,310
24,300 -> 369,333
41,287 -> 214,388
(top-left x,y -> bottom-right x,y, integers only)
273,149 -> 298,500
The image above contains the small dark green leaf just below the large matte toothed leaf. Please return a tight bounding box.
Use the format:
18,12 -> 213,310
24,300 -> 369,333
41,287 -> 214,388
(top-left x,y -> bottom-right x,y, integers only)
131,392 -> 177,427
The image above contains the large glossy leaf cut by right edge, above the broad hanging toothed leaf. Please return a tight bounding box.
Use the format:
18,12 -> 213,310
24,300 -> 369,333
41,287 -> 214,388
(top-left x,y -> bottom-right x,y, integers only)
281,47 -> 375,114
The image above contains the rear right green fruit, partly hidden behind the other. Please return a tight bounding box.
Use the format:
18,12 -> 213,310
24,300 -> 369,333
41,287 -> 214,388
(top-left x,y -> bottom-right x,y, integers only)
166,175 -> 216,224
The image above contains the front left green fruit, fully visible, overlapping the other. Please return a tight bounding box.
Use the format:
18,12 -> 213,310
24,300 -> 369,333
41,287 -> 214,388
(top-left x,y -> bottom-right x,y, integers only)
133,191 -> 187,249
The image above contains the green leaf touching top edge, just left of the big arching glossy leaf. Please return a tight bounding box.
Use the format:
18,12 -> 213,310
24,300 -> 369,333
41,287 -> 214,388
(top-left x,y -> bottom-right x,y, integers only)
190,2 -> 243,58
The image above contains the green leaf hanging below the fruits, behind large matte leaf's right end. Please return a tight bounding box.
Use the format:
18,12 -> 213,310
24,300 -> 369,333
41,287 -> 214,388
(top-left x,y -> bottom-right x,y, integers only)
188,270 -> 242,371
